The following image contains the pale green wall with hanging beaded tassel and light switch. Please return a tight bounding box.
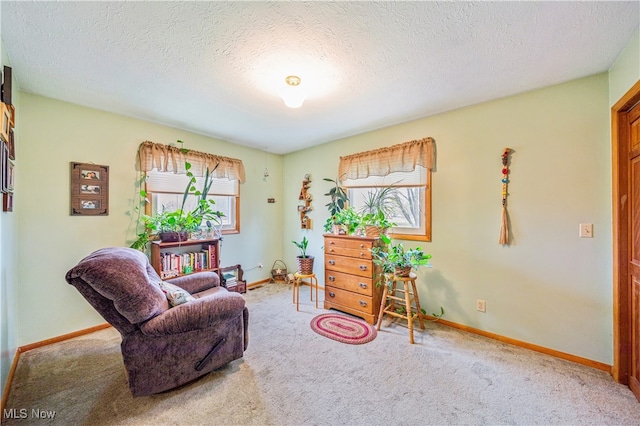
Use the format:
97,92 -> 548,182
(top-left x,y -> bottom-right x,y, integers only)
284,74 -> 612,363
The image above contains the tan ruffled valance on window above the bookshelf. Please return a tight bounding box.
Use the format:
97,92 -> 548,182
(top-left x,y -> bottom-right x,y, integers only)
138,141 -> 246,182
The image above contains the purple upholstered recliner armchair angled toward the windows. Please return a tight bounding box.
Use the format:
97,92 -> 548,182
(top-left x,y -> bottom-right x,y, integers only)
66,247 -> 249,396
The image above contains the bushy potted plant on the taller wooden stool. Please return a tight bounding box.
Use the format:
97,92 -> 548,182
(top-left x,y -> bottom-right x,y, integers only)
371,234 -> 431,284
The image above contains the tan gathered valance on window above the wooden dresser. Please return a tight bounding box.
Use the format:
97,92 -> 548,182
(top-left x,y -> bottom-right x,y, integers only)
338,138 -> 435,180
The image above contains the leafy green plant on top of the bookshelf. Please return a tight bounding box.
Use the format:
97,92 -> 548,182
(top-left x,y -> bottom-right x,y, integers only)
131,162 -> 224,250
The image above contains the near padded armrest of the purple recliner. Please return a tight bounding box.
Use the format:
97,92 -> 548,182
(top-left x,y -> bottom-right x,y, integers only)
140,291 -> 245,336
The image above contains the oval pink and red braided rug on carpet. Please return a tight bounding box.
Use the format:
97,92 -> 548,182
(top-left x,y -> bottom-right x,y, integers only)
311,314 -> 377,345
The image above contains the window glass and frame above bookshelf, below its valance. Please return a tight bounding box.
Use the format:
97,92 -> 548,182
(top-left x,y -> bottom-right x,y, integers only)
146,169 -> 240,234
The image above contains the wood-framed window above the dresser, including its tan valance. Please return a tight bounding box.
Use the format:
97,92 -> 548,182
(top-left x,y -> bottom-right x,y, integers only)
339,138 -> 434,241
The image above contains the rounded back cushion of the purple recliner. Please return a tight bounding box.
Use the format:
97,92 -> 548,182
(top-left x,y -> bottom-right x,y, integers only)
66,247 -> 169,324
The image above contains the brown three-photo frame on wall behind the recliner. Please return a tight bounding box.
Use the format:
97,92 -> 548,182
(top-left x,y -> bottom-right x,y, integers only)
70,162 -> 109,216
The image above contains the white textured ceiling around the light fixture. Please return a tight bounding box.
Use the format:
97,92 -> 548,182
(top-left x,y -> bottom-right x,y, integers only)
1,1 -> 640,154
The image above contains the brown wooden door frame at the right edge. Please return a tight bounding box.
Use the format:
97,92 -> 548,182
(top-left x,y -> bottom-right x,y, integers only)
611,80 -> 640,385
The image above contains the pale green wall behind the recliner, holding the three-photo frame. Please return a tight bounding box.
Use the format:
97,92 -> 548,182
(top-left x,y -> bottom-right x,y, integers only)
15,93 -> 282,345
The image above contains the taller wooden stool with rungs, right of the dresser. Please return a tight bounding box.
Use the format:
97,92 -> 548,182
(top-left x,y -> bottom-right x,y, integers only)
377,272 -> 424,344
